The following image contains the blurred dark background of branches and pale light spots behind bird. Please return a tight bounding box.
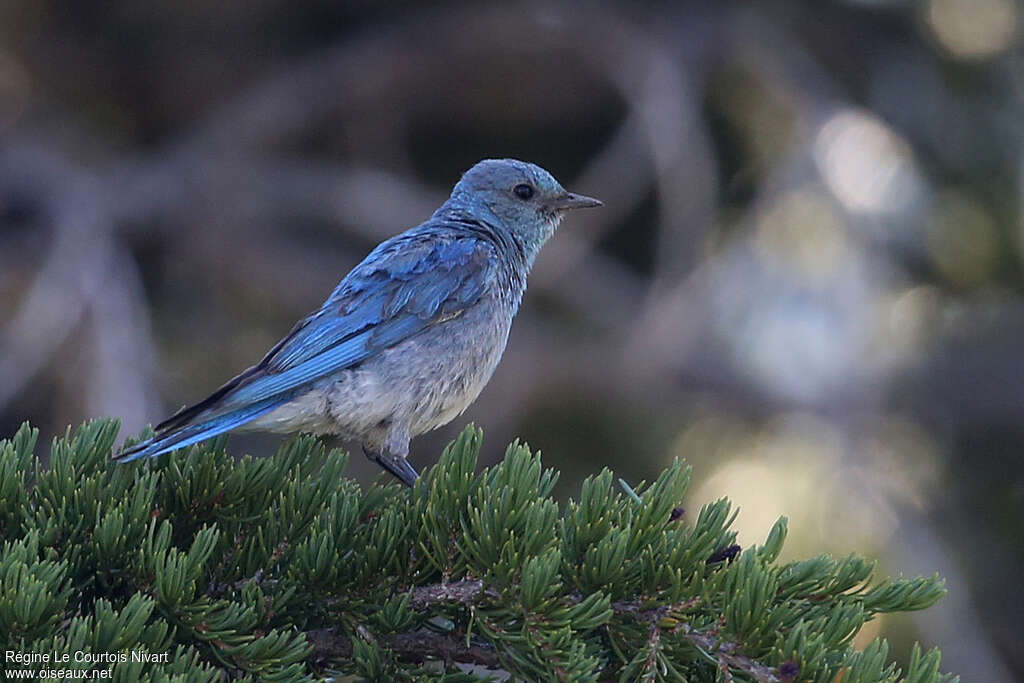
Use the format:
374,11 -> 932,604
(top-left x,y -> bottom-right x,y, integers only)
0,0 -> 1024,683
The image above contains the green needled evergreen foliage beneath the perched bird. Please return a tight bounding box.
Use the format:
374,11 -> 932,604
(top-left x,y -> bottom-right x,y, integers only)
0,421 -> 955,683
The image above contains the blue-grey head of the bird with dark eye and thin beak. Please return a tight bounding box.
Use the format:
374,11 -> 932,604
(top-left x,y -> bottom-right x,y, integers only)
447,159 -> 601,260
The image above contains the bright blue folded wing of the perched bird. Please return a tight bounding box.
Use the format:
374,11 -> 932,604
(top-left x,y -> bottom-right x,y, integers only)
157,232 -> 498,432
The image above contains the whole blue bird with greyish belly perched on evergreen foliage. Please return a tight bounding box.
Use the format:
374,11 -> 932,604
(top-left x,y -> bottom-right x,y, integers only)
114,159 -> 602,486
